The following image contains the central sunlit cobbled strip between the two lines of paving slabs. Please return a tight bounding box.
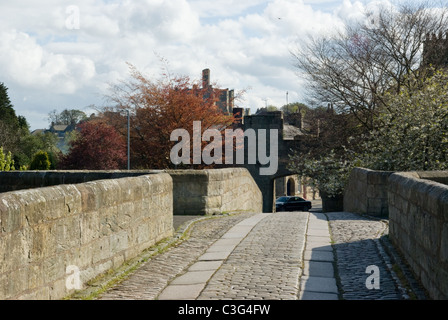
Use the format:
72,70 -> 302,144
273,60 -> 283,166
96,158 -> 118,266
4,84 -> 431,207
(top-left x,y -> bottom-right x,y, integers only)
199,212 -> 308,300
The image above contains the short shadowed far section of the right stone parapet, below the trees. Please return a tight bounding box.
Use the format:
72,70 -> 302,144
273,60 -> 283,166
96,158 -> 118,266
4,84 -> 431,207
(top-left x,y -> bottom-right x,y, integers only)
344,168 -> 392,217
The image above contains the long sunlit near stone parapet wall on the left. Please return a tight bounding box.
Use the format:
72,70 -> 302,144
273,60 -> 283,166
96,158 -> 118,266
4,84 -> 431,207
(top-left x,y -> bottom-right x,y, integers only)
0,173 -> 173,300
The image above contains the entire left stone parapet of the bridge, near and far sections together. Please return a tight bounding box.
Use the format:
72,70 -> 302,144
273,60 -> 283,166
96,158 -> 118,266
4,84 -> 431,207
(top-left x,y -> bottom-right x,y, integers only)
0,168 -> 262,300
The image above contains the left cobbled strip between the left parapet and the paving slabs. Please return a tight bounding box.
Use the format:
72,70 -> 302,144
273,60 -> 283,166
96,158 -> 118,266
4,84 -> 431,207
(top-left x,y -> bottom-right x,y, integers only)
100,213 -> 253,300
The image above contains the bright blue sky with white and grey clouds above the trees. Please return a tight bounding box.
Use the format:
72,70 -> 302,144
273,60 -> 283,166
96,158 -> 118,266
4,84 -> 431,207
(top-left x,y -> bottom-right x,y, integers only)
0,0 -> 384,130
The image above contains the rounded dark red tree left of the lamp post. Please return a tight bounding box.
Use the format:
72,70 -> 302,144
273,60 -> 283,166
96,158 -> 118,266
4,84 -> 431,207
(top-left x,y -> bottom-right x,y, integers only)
59,121 -> 126,170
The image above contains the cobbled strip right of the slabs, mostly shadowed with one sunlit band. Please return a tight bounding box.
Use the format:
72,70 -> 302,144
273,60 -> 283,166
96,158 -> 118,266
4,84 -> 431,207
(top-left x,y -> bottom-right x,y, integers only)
327,212 -> 407,300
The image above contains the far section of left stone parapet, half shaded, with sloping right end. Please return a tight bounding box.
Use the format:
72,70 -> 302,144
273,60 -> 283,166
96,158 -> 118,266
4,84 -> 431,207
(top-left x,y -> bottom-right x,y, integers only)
167,168 -> 263,215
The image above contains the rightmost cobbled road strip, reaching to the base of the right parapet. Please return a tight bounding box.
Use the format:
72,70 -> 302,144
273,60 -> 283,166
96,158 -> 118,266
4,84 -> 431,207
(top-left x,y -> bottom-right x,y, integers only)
326,212 -> 425,300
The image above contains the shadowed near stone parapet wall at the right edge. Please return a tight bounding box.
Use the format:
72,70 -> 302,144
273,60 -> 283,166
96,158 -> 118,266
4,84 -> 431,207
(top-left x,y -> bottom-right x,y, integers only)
388,172 -> 448,299
